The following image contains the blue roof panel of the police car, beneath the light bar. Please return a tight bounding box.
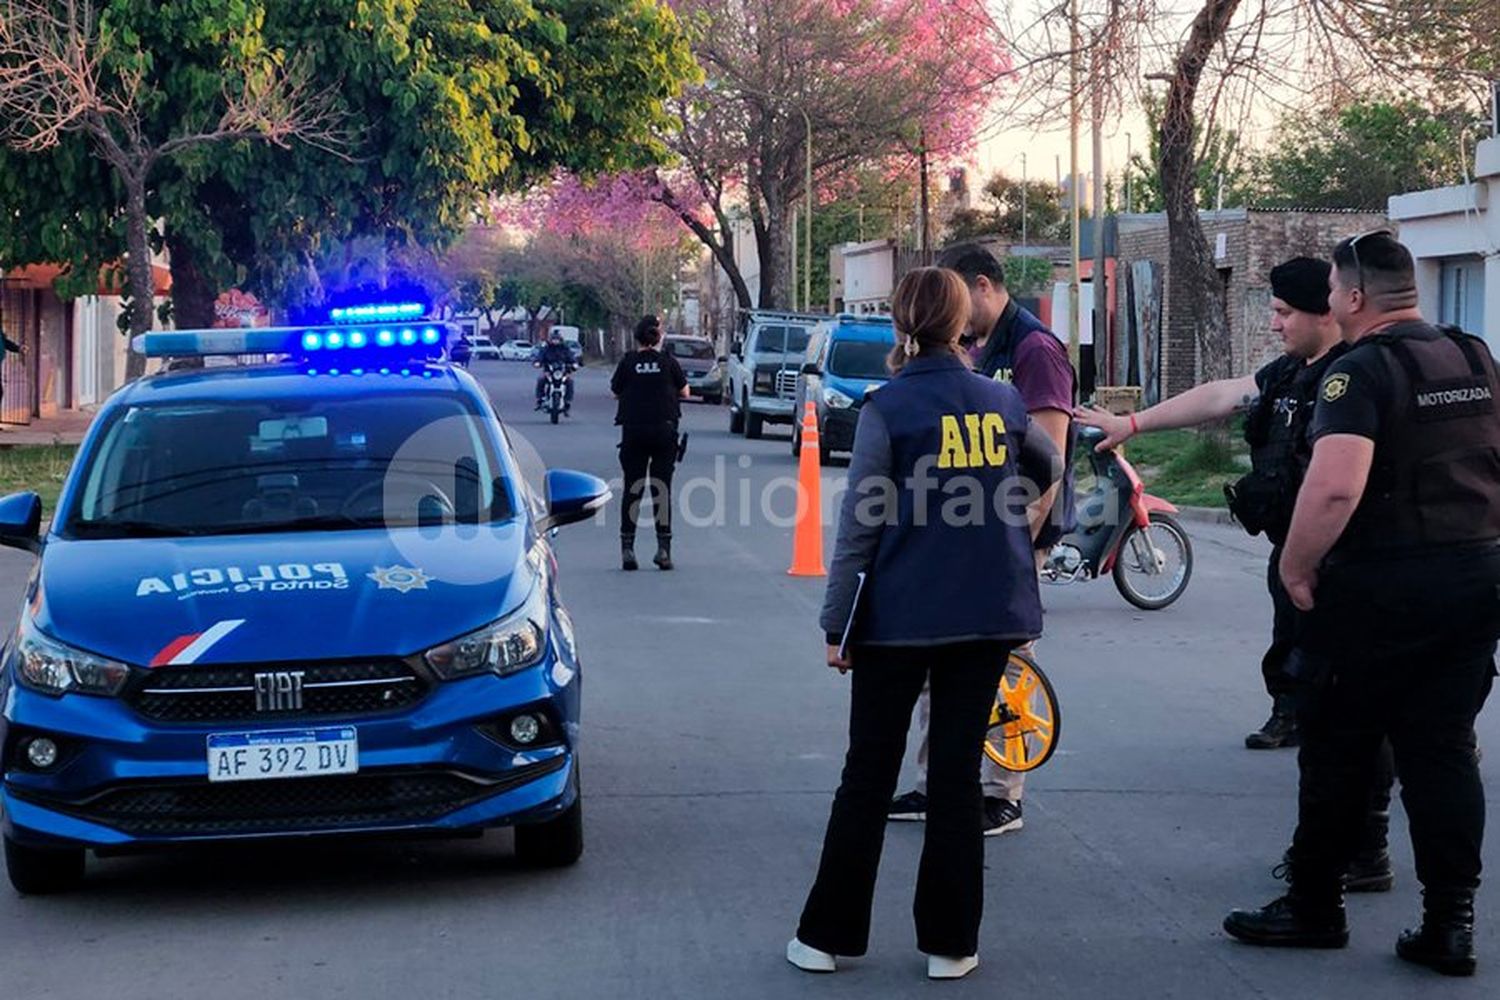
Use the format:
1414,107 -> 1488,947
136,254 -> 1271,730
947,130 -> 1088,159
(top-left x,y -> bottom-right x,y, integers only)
108,363 -> 477,406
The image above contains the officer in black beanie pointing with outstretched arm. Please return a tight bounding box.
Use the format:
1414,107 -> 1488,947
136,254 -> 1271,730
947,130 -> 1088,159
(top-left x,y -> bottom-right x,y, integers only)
1077,256 -> 1394,892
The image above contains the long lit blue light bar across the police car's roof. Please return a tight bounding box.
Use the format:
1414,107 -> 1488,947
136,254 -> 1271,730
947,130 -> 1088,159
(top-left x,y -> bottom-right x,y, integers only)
131,322 -> 449,360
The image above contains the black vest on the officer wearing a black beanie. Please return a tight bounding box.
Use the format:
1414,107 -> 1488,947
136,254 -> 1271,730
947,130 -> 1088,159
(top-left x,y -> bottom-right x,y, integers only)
1227,345 -> 1344,546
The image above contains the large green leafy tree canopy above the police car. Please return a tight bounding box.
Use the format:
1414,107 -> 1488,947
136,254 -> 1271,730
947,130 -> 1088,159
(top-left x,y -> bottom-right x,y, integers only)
0,0 -> 693,359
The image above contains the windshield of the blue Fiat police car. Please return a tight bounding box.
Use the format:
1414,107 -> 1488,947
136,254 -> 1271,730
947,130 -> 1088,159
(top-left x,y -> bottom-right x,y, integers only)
65,393 -> 513,538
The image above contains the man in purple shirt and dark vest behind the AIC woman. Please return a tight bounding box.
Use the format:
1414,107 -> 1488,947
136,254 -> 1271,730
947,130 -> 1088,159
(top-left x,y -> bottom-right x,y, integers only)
888,243 -> 1079,837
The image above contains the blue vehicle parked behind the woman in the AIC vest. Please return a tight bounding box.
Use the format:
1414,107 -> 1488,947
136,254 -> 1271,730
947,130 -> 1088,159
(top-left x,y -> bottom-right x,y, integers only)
792,313 -> 896,465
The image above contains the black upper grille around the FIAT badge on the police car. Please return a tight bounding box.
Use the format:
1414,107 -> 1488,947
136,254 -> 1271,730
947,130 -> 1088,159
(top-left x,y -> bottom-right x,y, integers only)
128,660 -> 428,723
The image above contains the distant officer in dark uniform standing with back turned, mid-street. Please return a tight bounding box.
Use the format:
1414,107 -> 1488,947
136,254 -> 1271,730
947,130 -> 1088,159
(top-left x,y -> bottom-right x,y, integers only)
609,316 -> 689,570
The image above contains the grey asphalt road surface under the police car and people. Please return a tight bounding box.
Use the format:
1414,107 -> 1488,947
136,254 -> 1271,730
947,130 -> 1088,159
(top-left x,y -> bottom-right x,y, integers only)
0,363 -> 1500,1000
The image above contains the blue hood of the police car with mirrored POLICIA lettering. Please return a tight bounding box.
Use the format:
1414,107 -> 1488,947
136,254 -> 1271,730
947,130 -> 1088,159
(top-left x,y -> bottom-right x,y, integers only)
30,522 -> 546,666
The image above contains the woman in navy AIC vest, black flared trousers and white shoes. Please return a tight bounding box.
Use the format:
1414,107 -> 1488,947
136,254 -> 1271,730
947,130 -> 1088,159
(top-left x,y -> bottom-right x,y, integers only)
786,267 -> 1056,979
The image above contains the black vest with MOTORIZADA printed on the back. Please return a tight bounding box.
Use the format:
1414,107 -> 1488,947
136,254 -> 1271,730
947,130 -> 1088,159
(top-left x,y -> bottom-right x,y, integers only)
1338,324 -> 1500,555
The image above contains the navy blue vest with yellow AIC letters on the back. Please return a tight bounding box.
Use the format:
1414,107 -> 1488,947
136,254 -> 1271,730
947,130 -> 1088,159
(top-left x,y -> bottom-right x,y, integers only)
860,357 -> 1041,645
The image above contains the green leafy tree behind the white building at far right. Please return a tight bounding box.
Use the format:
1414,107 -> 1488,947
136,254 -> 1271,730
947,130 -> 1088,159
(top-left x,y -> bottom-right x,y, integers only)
1253,100 -> 1484,211
